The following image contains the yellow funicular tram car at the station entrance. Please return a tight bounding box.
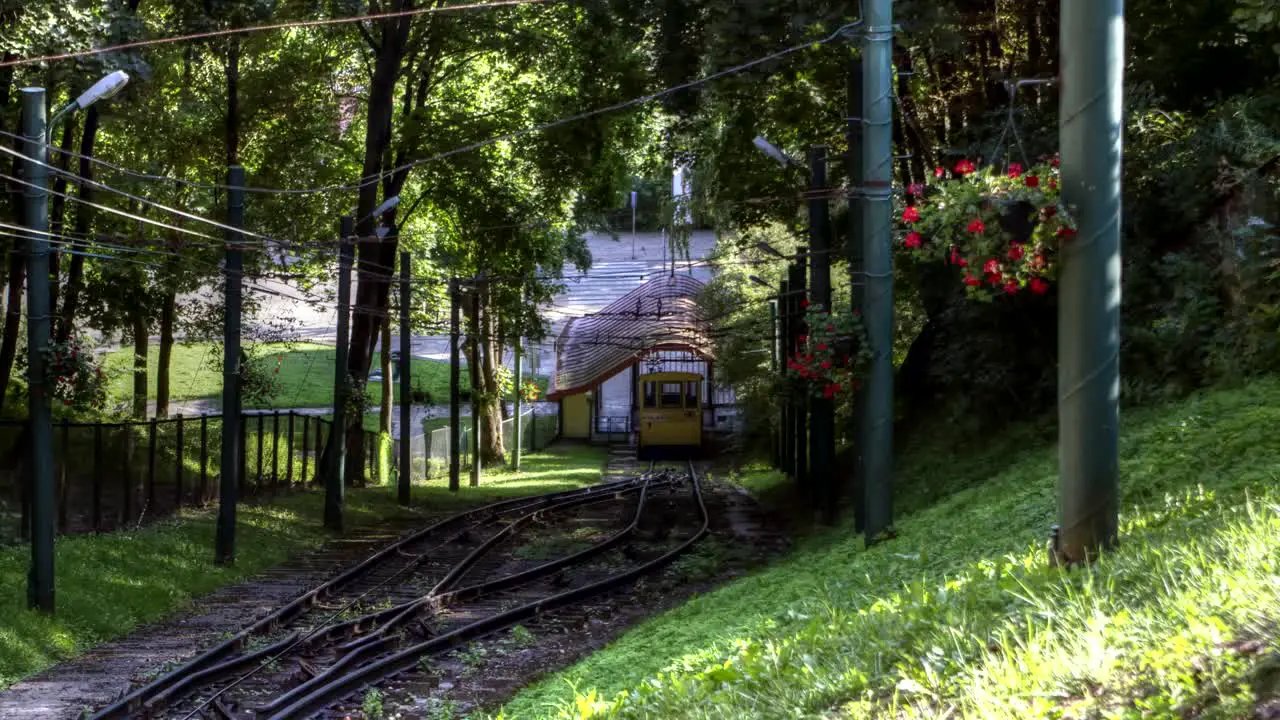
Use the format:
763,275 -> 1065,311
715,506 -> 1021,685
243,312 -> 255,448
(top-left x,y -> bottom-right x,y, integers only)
636,373 -> 703,459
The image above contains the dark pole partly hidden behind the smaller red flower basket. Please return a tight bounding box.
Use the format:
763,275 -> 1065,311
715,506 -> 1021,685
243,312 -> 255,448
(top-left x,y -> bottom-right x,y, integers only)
809,145 -> 840,523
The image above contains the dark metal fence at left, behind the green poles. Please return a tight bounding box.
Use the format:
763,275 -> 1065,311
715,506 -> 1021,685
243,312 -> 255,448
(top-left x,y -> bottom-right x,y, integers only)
0,411 -> 378,543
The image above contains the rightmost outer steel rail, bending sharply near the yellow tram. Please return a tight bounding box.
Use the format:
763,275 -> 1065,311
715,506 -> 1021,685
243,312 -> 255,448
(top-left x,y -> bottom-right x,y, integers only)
270,462 -> 710,720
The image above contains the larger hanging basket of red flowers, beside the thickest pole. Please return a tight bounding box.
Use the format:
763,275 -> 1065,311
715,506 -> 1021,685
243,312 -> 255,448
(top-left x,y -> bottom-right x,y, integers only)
897,156 -> 1076,300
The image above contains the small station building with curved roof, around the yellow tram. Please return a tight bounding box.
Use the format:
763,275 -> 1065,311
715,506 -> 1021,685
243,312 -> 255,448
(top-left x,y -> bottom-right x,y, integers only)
547,273 -> 714,439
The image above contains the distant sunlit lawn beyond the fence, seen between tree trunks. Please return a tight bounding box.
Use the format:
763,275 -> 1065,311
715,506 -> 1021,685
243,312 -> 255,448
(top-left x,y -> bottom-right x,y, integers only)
104,342 -> 460,409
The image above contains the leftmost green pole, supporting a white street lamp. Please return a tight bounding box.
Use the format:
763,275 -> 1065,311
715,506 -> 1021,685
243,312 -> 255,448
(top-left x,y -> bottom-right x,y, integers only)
22,87 -> 55,612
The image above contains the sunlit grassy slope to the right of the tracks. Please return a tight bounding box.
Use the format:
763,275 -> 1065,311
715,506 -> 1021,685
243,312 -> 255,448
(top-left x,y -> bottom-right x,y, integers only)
504,379 -> 1280,719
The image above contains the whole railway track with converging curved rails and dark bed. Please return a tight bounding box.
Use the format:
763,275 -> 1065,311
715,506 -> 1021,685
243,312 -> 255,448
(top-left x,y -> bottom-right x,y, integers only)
93,464 -> 709,720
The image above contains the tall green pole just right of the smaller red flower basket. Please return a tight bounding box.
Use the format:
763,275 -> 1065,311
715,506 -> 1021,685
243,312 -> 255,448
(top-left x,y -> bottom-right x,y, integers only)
861,0 -> 893,543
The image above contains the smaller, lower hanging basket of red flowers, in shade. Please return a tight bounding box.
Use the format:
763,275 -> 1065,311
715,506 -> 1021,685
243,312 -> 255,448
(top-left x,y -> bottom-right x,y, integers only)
787,301 -> 872,400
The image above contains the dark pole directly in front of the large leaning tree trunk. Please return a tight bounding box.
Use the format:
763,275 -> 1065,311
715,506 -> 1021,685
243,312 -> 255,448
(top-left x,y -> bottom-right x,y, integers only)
324,215 -> 355,533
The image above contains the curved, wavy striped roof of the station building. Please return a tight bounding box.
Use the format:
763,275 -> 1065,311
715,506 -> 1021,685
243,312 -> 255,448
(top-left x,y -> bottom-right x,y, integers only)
547,274 -> 712,400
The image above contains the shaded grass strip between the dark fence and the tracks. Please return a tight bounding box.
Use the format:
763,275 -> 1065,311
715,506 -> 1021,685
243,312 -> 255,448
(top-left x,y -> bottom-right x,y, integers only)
0,446 -> 605,688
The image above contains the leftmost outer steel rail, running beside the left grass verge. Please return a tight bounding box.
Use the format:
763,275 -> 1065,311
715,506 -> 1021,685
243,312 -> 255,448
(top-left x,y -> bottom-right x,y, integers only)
90,478 -> 650,720
